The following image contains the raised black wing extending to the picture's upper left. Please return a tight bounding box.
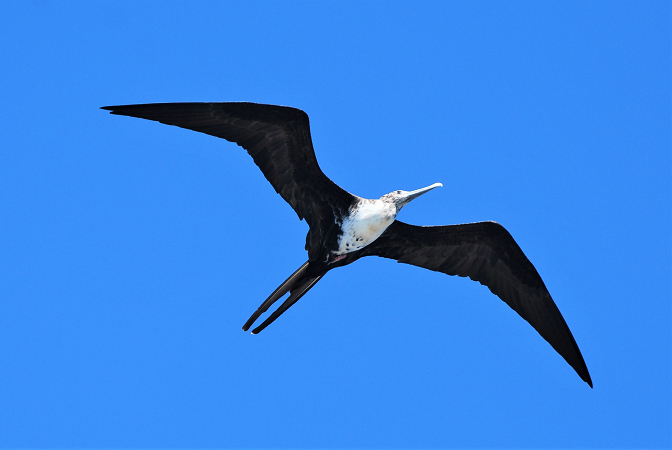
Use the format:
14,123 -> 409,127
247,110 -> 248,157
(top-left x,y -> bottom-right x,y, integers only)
102,102 -> 353,236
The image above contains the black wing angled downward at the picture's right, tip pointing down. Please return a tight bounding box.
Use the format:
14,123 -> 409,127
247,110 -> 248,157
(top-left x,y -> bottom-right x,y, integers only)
361,221 -> 593,387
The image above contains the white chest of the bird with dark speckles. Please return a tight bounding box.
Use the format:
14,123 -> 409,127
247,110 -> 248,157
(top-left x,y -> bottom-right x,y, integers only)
335,200 -> 397,255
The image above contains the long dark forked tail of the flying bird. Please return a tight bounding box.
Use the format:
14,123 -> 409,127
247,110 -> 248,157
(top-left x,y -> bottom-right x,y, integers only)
243,261 -> 324,334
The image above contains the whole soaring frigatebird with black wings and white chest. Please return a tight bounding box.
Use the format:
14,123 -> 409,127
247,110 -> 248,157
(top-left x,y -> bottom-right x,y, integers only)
102,102 -> 593,387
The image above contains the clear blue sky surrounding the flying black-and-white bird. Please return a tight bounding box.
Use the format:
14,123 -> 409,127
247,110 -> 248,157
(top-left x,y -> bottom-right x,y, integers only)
0,0 -> 672,448
